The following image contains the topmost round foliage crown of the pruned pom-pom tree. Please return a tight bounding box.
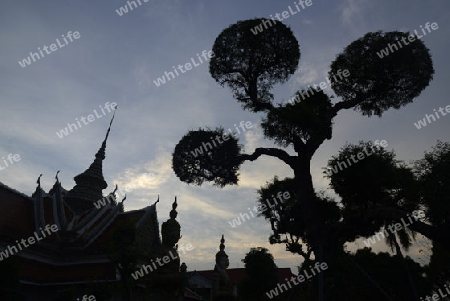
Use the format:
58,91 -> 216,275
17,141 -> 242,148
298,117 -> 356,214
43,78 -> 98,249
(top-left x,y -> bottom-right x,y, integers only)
209,19 -> 300,112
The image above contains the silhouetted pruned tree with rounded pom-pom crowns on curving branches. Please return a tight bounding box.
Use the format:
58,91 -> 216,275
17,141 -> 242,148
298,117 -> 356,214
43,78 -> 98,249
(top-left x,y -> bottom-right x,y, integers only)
173,19 -> 434,298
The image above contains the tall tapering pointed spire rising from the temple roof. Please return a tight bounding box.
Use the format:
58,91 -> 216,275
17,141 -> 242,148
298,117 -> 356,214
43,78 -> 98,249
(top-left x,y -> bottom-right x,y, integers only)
65,107 -> 117,214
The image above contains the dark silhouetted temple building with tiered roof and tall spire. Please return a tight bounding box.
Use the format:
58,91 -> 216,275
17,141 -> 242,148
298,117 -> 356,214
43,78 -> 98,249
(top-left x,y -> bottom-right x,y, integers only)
0,111 -> 191,301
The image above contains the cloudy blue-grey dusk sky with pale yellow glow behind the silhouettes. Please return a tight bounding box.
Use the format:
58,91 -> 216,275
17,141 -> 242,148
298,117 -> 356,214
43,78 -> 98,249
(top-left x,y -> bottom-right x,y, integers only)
0,0 -> 450,272
